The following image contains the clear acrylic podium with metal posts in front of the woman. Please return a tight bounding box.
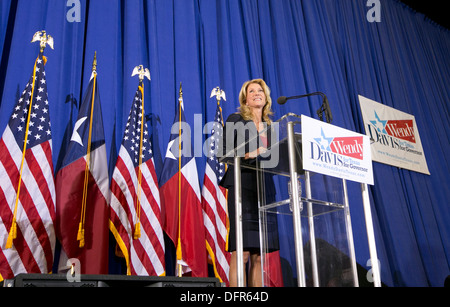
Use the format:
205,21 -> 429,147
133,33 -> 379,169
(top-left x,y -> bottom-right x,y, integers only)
221,113 -> 358,287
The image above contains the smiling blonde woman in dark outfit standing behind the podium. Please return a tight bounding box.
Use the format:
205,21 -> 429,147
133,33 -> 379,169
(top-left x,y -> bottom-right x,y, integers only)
221,79 -> 279,287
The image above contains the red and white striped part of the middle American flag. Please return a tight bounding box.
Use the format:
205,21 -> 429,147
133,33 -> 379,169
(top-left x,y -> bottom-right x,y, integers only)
110,146 -> 165,276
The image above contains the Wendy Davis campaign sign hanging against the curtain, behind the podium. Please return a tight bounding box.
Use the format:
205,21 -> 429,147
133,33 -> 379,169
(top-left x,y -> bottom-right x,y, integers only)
359,96 -> 430,175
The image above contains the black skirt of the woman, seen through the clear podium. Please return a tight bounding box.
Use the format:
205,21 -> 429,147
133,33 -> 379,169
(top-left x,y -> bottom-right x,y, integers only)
228,187 -> 280,254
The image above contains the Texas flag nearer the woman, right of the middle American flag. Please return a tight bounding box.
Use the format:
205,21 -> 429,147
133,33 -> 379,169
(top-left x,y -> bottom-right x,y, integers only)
160,90 -> 208,277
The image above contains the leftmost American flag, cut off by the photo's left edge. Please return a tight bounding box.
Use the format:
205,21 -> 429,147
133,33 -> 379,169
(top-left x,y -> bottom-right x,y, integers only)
0,52 -> 56,280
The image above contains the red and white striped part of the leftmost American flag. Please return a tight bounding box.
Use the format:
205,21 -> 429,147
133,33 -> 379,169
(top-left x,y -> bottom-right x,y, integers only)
0,126 -> 55,280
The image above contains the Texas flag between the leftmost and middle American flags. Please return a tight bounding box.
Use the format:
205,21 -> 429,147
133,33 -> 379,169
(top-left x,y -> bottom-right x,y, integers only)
56,72 -> 110,274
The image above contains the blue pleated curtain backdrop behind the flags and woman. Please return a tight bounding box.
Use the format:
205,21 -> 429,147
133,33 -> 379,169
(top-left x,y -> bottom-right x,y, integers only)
0,0 -> 450,286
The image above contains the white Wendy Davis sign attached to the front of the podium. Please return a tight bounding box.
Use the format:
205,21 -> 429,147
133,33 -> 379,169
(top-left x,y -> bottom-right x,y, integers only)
301,115 -> 373,185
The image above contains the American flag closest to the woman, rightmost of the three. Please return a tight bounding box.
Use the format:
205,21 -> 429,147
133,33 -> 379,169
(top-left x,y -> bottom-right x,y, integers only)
202,106 -> 231,285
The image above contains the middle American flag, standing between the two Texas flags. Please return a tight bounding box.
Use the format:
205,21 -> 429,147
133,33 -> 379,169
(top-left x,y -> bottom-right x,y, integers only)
110,85 -> 165,276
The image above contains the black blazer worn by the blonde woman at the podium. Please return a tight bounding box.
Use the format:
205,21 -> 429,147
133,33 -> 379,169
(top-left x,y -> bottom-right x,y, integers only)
220,113 -> 275,194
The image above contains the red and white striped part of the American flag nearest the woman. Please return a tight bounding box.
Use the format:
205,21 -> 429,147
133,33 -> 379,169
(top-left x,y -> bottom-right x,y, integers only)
202,163 -> 231,285
